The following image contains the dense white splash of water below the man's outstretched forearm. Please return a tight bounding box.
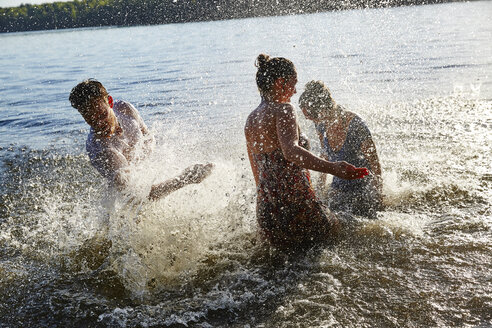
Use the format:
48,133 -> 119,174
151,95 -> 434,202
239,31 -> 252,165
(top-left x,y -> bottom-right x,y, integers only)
104,159 -> 254,293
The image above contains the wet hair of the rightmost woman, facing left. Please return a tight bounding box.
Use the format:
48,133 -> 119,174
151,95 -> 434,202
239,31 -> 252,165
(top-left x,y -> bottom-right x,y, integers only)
299,81 -> 335,119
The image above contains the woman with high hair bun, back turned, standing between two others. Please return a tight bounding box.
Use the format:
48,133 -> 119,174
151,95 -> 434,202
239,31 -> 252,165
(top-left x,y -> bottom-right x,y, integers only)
244,54 -> 368,247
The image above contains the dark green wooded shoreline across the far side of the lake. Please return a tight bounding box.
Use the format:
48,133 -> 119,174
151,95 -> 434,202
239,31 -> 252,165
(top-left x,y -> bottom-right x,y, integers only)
0,0 -> 467,33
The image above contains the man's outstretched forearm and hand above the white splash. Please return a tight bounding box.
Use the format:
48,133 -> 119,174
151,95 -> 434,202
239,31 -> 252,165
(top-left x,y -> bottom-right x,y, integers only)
148,163 -> 214,200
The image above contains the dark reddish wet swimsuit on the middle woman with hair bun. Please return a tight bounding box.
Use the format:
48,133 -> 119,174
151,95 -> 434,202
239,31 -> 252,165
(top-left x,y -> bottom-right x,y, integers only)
253,149 -> 334,247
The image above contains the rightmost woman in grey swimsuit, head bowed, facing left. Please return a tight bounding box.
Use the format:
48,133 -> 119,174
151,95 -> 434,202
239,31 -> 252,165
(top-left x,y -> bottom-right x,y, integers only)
299,81 -> 382,218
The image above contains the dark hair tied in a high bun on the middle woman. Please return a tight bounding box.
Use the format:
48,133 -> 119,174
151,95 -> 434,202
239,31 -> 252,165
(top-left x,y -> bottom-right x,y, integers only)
255,54 -> 297,94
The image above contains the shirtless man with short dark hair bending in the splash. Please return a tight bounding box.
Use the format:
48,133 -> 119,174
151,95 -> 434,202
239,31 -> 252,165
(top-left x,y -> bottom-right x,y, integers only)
69,79 -> 213,200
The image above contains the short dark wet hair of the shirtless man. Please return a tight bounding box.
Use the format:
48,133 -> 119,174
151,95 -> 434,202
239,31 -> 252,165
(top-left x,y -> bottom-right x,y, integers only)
68,79 -> 108,115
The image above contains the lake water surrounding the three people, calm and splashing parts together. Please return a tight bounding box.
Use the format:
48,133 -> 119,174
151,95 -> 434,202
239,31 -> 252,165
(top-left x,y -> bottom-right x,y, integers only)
0,1 -> 492,327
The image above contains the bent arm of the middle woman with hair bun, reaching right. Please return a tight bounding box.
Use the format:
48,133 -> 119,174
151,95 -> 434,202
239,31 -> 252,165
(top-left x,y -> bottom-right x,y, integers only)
276,104 -> 367,179
